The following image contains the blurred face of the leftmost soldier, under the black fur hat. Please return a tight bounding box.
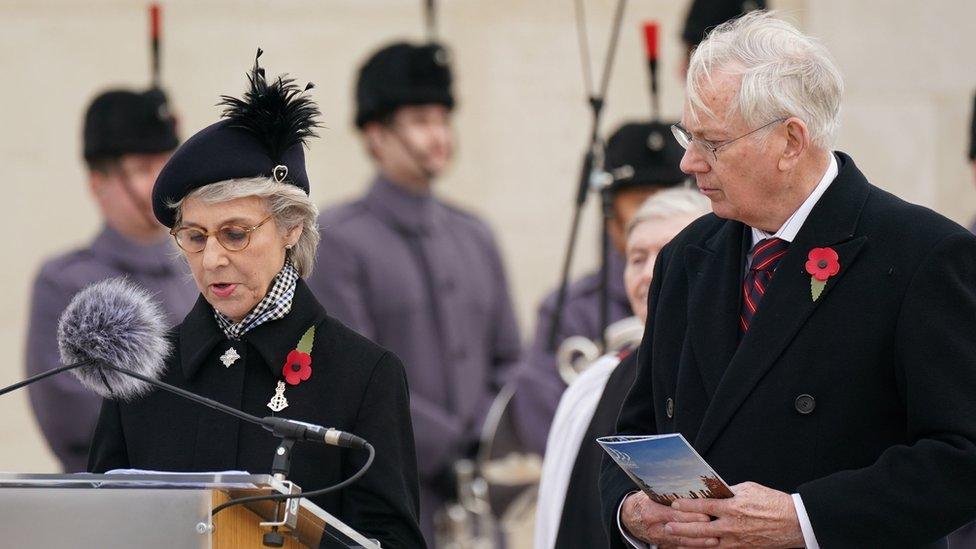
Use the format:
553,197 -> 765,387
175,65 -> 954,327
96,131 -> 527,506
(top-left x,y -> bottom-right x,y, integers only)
91,153 -> 170,242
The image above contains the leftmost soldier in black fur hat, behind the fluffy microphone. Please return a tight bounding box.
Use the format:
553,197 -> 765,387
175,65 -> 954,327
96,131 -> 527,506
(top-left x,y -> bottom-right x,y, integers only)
25,89 -> 197,472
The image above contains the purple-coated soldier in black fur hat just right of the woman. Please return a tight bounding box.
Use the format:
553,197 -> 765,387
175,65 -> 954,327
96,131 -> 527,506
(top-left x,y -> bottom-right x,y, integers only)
308,43 -> 520,545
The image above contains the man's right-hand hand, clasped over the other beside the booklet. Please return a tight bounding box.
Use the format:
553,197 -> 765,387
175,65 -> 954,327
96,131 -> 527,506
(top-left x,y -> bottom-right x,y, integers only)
664,482 -> 804,547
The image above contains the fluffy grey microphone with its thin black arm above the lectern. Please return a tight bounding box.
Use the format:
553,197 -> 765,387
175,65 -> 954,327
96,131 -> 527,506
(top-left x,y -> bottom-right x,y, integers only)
37,277 -> 368,448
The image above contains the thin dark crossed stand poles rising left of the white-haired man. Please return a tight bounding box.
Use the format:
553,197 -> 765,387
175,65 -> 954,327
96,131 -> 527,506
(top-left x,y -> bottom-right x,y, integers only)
547,0 -> 626,353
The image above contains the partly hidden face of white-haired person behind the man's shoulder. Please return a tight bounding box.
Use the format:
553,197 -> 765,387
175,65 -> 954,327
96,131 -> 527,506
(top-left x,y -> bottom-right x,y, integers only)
624,214 -> 698,322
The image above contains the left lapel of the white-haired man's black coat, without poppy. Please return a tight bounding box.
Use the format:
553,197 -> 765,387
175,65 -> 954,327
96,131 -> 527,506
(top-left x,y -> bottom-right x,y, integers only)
685,222 -> 748,397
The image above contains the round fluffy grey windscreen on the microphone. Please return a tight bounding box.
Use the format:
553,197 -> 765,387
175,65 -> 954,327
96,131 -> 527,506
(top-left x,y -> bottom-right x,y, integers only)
58,277 -> 170,400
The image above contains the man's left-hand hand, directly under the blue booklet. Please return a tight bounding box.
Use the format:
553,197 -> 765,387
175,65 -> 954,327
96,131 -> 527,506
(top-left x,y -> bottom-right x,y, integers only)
620,492 -> 718,547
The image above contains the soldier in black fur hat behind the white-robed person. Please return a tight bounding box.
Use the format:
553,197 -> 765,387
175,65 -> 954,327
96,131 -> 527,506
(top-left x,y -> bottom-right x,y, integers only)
512,122 -> 687,454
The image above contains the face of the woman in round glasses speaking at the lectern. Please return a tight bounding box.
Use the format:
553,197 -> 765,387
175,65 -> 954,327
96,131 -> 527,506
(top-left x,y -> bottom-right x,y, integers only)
180,196 -> 302,322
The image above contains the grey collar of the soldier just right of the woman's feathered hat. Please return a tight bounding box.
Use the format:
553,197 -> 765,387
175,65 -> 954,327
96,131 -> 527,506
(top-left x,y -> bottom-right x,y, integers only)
366,174 -> 437,235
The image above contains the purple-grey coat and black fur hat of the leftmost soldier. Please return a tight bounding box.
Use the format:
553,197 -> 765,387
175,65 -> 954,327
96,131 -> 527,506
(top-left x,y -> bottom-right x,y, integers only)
25,89 -> 189,472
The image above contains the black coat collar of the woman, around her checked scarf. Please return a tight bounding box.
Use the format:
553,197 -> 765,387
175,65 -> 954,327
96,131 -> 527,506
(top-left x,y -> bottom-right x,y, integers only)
179,279 -> 326,379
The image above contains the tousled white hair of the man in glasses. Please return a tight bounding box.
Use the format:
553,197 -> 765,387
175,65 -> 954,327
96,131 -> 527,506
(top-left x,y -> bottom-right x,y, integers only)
687,11 -> 844,150
